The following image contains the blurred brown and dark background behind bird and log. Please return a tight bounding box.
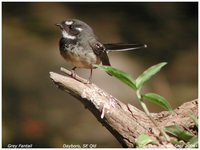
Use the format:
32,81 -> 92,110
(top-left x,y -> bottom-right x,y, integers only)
2,2 -> 198,148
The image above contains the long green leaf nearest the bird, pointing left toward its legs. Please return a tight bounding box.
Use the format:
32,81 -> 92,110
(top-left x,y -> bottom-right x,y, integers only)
94,65 -> 137,90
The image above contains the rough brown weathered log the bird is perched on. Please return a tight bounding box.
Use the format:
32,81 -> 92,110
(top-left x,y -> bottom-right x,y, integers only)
50,68 -> 198,147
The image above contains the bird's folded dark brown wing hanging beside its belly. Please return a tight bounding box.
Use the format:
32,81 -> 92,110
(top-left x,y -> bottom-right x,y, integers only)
89,41 -> 111,66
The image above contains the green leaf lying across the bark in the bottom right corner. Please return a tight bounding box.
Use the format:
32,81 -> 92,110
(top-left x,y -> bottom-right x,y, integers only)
164,125 -> 193,142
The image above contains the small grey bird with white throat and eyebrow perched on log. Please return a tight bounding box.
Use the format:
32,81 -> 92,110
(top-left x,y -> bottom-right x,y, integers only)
56,19 -> 147,83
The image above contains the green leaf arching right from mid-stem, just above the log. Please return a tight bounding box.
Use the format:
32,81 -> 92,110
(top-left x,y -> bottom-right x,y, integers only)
142,93 -> 172,111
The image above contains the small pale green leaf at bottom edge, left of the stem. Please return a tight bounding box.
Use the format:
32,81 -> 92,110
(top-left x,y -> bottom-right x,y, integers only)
135,134 -> 155,148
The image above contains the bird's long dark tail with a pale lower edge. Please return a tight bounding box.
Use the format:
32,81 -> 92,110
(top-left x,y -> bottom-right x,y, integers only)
103,43 -> 147,52
